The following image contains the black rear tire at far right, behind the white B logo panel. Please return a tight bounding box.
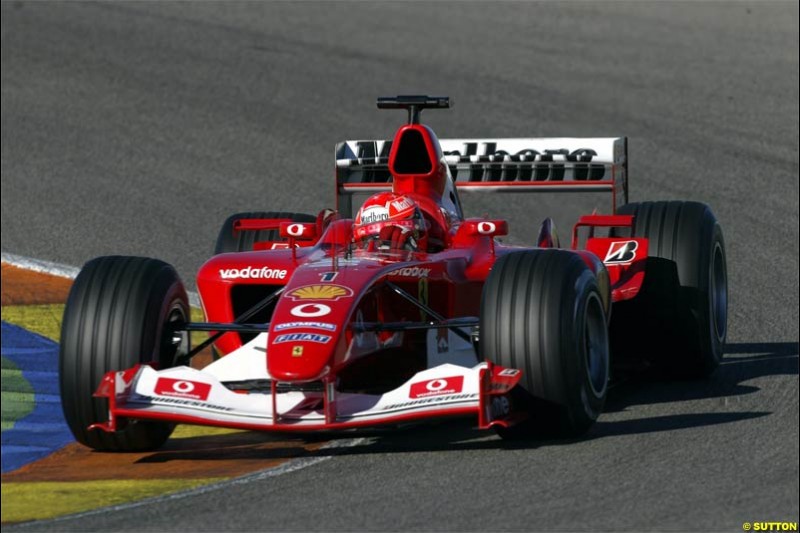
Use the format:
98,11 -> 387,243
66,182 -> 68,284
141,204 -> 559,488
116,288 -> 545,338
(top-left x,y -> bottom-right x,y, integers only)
611,201 -> 728,378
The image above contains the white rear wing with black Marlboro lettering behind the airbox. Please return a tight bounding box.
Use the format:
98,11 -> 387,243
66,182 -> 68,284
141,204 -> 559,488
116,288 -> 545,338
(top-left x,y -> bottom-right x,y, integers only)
336,137 -> 628,217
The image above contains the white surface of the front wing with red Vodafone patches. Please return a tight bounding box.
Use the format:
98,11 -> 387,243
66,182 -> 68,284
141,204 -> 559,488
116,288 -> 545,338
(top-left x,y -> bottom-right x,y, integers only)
115,356 -> 488,426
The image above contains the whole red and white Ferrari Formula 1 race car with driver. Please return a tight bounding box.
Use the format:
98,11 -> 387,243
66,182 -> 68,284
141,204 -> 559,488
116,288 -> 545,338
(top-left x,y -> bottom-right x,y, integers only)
60,96 -> 727,451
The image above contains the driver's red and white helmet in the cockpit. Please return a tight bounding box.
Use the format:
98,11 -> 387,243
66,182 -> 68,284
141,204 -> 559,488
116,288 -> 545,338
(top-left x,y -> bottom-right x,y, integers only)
353,192 -> 427,251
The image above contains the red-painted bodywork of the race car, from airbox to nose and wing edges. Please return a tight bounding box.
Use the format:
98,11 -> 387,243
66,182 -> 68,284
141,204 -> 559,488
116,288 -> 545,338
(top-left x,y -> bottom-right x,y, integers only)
89,116 -> 647,431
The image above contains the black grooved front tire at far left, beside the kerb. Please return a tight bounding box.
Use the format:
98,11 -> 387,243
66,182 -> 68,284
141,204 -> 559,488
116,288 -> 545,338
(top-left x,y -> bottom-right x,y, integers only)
59,256 -> 189,452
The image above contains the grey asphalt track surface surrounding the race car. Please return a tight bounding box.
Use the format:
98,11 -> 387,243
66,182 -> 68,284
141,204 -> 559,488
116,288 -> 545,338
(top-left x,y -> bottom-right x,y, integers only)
0,2 -> 798,531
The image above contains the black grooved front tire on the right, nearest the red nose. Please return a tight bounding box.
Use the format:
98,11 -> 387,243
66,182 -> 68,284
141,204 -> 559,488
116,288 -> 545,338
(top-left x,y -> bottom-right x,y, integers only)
480,250 -> 610,438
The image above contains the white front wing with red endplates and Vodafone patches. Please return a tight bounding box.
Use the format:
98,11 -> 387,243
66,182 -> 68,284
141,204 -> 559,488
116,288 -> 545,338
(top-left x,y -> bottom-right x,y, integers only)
91,362 -> 522,432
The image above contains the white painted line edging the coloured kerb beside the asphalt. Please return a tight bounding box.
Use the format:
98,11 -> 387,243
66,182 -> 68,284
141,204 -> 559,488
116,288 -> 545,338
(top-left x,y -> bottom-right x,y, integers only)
0,252 -> 367,529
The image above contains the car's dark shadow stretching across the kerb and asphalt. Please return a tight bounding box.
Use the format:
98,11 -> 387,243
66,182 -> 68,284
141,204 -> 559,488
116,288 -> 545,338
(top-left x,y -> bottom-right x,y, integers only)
140,342 -> 798,463
